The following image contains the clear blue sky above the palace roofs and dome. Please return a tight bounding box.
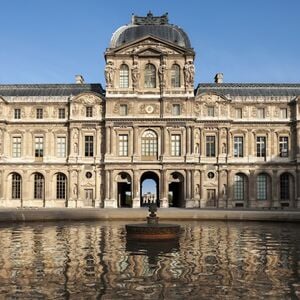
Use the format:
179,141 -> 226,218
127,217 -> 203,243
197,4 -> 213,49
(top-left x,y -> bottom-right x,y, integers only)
0,0 -> 300,84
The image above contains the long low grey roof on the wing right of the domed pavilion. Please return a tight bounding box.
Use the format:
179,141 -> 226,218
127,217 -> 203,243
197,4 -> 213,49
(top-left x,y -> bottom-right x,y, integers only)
195,83 -> 300,97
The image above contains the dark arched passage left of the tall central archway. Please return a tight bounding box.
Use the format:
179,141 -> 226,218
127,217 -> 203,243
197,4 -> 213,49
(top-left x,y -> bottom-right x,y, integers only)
117,172 -> 132,207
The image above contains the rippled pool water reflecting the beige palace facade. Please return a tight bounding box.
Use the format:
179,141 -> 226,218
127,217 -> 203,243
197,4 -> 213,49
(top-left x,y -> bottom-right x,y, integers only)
0,222 -> 300,300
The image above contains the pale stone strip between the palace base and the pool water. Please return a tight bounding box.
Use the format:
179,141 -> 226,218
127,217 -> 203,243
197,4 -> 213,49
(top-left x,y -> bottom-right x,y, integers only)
0,208 -> 300,222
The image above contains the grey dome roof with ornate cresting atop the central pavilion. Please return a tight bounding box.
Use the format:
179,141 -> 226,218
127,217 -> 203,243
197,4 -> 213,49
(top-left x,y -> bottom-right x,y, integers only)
109,12 -> 191,49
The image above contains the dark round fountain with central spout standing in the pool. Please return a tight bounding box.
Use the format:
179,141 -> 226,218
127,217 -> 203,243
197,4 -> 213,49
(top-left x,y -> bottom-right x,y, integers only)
125,202 -> 180,241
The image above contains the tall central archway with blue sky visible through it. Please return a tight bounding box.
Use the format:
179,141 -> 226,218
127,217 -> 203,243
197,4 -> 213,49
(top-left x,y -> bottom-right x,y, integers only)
140,172 -> 159,206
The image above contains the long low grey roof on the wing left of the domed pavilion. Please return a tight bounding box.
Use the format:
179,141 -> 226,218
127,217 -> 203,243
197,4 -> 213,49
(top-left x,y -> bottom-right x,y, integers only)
0,83 -> 105,97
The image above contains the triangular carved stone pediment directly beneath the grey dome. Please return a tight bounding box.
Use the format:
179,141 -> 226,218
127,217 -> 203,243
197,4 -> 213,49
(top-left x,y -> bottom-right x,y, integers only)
112,35 -> 188,56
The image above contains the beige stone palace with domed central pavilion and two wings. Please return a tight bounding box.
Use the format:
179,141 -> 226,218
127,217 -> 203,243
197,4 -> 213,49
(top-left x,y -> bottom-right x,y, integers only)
0,13 -> 300,208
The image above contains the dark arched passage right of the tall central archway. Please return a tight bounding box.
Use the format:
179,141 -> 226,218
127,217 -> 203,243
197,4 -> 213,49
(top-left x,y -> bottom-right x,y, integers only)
168,172 -> 184,207
